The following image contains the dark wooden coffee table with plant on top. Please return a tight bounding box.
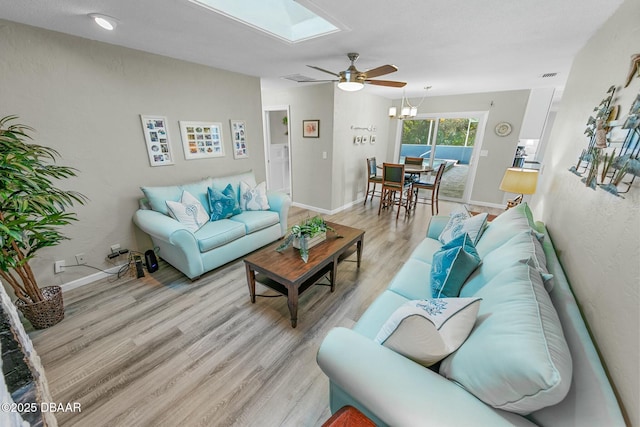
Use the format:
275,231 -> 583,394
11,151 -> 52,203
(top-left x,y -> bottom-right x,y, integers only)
244,222 -> 364,328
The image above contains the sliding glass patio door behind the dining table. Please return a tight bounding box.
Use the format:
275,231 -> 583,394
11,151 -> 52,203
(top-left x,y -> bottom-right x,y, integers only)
397,112 -> 486,203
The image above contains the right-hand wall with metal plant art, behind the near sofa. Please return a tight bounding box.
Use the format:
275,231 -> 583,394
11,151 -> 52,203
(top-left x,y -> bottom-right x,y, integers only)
532,0 -> 640,426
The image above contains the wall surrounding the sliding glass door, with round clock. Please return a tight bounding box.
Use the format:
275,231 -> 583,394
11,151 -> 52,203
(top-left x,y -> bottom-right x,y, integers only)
387,90 -> 530,206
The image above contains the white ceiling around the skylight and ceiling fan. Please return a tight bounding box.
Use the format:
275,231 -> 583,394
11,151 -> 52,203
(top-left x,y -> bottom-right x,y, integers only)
0,0 -> 623,99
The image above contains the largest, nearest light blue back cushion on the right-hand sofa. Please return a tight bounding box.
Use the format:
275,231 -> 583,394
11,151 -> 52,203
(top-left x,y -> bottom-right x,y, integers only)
440,262 -> 572,415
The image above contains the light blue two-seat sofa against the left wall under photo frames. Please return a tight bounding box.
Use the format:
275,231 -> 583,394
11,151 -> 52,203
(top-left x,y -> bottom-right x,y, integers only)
133,171 -> 291,280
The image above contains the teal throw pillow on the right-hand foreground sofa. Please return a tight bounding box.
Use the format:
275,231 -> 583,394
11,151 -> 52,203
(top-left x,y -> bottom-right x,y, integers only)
431,233 -> 482,298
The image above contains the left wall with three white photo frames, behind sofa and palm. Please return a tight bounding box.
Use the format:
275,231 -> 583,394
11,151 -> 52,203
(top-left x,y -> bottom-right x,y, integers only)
0,21 -> 265,286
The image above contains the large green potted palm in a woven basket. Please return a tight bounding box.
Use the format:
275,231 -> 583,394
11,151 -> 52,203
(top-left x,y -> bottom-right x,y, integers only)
0,116 -> 86,329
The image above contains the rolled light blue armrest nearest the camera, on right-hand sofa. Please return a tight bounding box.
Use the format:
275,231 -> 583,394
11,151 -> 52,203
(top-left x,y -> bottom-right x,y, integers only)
317,328 -> 534,427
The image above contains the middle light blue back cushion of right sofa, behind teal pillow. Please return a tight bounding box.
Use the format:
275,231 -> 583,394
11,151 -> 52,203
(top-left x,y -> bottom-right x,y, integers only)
460,229 -> 553,297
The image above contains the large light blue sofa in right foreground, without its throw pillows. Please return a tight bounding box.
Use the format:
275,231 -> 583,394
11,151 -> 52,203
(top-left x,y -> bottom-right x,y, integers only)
317,204 -> 625,427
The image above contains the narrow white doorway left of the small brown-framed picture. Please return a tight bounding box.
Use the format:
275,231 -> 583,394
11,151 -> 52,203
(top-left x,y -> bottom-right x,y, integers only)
264,105 -> 291,195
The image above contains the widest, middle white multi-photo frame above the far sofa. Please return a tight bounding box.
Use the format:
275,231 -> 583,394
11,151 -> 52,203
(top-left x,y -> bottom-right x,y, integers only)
180,121 -> 224,160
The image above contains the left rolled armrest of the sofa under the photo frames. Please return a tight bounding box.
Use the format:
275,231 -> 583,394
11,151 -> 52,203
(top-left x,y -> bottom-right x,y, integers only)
133,209 -> 200,253
